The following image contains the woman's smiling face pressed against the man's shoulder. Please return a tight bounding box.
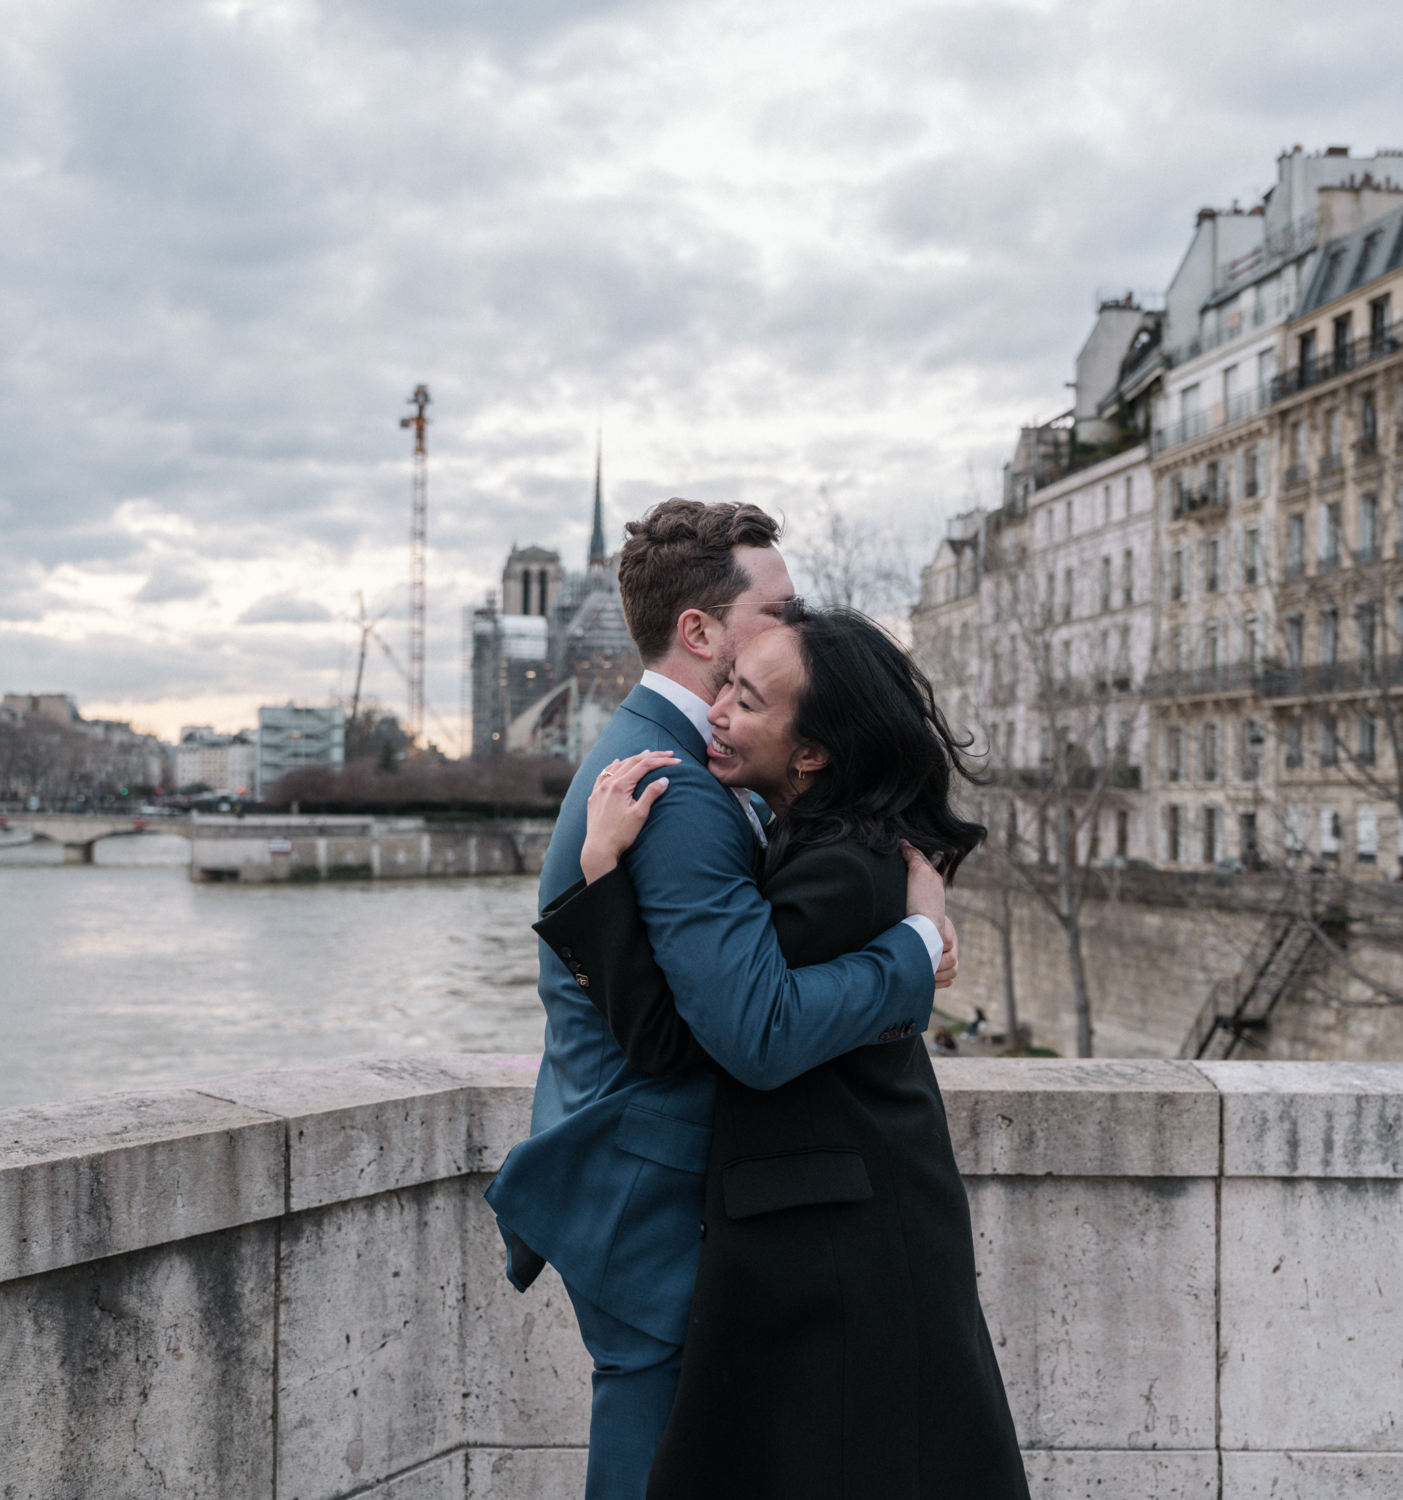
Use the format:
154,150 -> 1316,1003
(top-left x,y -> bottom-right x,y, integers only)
707,626 -> 827,809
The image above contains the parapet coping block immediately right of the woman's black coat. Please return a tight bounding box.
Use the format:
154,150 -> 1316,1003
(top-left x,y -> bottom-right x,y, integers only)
935,1058 -> 1218,1178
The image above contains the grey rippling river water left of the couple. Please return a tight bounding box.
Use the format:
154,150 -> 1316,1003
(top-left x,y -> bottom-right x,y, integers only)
0,834 -> 545,1107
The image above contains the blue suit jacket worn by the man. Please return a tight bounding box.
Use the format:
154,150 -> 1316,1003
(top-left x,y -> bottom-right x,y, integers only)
488,687 -> 935,1344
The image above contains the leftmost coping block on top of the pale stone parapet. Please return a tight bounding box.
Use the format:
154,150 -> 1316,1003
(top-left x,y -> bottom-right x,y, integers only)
0,1089 -> 284,1281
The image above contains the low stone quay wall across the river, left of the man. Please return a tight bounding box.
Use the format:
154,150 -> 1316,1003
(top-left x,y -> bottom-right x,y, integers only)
189,813 -> 555,885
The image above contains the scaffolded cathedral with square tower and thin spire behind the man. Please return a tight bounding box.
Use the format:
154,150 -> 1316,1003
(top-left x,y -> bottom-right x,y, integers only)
473,441 -> 642,761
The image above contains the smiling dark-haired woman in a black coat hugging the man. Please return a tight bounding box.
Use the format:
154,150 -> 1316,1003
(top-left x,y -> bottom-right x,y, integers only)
537,608 -> 1028,1500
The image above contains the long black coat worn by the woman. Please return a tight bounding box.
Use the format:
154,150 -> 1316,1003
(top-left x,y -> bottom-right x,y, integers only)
537,843 -> 1028,1500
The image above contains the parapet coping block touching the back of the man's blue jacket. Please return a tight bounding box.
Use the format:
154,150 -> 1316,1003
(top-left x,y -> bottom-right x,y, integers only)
201,1053 -> 537,1212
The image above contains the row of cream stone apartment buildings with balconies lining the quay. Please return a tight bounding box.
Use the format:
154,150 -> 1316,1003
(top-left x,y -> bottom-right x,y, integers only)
912,147 -> 1403,878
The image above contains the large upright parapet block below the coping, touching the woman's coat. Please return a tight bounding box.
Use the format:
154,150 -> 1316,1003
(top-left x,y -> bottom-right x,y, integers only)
966,1178 -> 1215,1449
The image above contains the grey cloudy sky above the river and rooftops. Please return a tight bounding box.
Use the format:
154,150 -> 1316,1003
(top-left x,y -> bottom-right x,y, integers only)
0,0 -> 1403,744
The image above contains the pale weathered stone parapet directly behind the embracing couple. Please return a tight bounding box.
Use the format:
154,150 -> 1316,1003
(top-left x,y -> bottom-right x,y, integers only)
0,1055 -> 1403,1500
